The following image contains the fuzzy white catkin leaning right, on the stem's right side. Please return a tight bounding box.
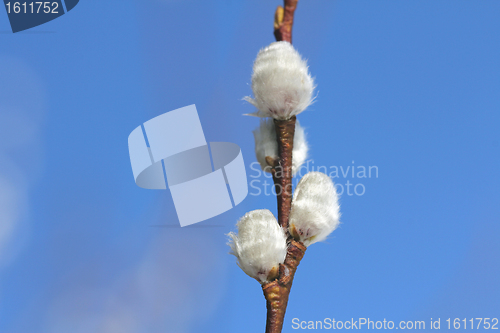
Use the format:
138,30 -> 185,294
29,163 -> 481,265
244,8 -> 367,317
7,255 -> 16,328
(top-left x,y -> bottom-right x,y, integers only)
289,172 -> 340,246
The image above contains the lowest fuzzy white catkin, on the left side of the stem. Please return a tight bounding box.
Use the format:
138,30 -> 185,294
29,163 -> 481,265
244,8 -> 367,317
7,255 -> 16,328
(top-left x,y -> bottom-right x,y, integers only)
228,209 -> 287,283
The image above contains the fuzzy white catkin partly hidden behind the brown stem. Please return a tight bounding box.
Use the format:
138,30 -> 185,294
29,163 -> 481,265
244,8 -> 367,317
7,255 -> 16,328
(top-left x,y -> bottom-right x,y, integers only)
253,119 -> 309,175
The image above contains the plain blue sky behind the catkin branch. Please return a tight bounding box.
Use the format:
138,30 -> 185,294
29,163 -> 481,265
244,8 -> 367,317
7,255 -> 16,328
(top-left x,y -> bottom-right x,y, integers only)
0,0 -> 500,333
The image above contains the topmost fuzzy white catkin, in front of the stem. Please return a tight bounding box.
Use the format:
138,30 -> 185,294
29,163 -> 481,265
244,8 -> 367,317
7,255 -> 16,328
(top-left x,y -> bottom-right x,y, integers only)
245,41 -> 314,120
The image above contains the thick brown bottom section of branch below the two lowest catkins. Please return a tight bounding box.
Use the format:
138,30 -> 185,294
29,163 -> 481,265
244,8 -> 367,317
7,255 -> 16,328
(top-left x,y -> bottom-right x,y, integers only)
262,240 -> 306,333
